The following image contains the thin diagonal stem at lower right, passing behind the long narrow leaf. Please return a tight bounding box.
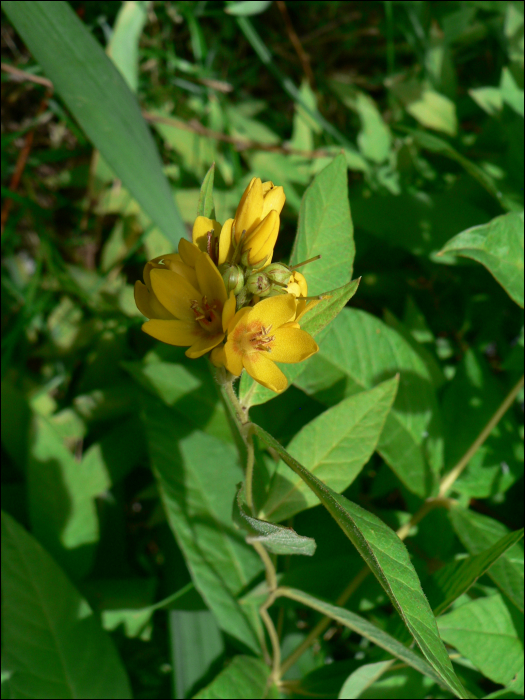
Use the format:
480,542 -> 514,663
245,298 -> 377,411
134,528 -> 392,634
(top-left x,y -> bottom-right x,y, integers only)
277,376 -> 523,675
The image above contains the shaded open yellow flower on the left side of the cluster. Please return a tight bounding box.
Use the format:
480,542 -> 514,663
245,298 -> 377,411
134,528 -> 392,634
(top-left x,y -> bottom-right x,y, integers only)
135,245 -> 230,358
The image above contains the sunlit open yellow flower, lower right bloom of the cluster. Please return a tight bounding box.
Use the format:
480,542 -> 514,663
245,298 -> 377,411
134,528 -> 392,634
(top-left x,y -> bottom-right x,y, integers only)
211,294 -> 319,393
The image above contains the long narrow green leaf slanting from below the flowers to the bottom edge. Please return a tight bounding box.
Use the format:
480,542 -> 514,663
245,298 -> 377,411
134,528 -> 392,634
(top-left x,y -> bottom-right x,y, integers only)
255,426 -> 468,698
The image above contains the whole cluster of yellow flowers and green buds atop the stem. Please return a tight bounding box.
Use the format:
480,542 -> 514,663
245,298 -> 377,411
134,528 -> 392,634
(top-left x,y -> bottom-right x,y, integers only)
135,178 -> 319,392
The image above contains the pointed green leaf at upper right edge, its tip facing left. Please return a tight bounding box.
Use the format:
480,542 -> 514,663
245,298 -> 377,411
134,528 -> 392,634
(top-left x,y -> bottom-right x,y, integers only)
440,212 -> 524,308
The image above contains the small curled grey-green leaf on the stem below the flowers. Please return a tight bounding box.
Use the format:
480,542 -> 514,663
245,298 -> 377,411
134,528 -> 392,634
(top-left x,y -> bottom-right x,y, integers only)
233,484 -> 316,557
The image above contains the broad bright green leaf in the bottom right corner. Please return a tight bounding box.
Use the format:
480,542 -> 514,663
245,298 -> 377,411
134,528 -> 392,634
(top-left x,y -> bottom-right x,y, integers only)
438,593 -> 523,685
